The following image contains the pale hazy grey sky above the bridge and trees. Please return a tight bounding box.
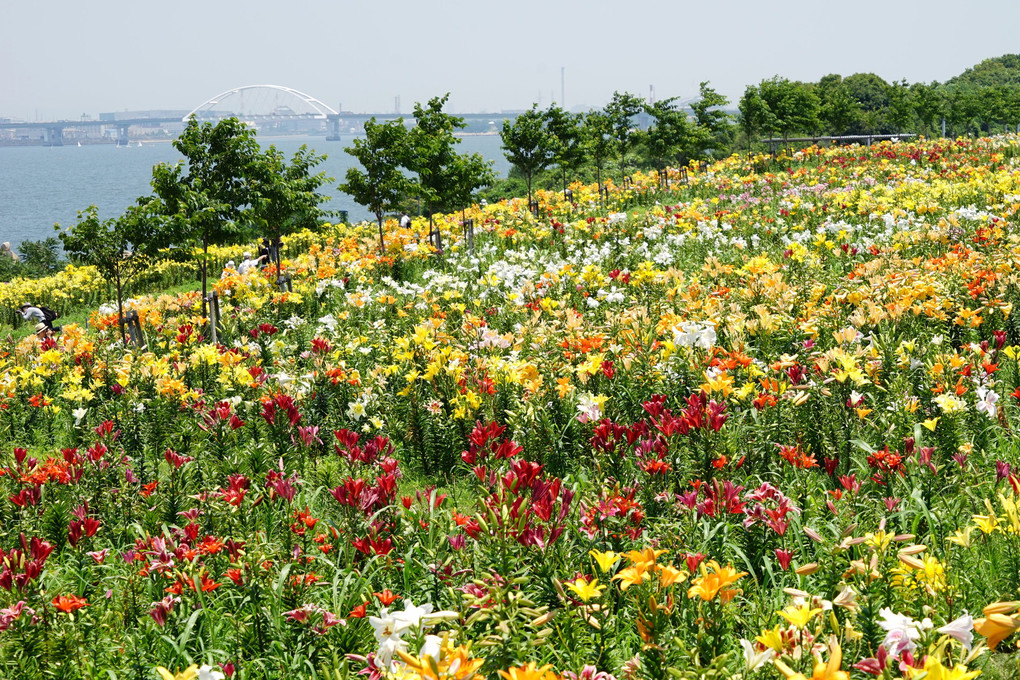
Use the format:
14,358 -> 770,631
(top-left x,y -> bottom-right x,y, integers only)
0,0 -> 1020,120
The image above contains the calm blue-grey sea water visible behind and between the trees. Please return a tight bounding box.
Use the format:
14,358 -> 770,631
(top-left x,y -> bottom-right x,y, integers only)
0,135 -> 509,249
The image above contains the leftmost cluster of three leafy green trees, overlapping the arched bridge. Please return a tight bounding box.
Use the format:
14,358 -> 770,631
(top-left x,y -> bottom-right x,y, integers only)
59,118 -> 329,333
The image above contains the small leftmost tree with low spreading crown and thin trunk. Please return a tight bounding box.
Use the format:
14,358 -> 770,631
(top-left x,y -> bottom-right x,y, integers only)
59,204 -> 164,339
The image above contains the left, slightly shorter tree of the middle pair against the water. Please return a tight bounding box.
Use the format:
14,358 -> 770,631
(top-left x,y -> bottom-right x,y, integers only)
340,118 -> 412,252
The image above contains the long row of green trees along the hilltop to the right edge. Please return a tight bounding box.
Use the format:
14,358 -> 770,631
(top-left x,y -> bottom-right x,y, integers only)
491,55 -> 1020,193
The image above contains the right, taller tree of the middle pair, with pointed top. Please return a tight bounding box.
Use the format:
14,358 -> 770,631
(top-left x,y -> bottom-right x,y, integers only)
404,93 -> 493,234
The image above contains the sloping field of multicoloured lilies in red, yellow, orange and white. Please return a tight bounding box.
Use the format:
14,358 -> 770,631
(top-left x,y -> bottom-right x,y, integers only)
0,136 -> 1020,680
